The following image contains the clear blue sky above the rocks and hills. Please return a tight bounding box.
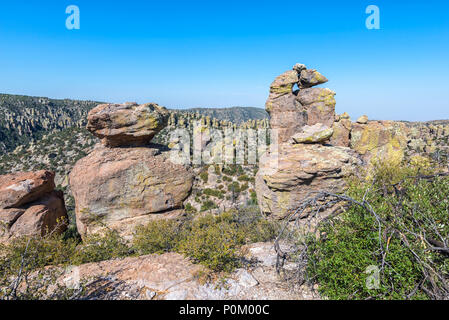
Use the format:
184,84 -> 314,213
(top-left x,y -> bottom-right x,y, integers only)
0,0 -> 449,120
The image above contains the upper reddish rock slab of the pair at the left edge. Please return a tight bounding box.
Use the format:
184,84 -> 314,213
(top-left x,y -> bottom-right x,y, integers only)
0,170 -> 55,209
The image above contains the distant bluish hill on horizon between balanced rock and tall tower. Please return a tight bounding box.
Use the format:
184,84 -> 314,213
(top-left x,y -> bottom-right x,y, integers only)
176,107 -> 268,124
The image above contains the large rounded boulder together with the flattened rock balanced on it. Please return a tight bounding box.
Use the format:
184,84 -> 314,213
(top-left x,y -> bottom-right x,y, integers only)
70,103 -> 193,237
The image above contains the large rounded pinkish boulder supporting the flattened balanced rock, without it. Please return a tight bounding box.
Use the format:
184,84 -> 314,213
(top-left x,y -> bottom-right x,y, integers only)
70,144 -> 193,237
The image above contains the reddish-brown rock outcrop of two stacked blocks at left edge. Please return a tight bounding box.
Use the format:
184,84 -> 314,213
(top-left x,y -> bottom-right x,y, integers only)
0,171 -> 68,242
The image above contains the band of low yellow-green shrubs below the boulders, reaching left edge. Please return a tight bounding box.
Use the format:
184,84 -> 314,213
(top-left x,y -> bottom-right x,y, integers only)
0,207 -> 279,300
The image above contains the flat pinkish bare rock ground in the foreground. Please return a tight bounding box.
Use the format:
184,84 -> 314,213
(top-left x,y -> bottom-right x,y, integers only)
61,242 -> 319,300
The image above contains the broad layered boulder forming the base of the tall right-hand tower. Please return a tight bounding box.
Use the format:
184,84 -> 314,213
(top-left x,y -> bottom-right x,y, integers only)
256,143 -> 361,219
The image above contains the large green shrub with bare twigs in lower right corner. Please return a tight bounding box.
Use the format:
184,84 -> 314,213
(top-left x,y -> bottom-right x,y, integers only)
307,162 -> 449,299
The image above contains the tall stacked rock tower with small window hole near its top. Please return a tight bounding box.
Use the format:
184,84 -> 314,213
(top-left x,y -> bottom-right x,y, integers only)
256,64 -> 361,219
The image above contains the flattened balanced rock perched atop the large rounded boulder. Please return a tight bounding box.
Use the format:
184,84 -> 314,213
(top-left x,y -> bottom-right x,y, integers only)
87,103 -> 169,147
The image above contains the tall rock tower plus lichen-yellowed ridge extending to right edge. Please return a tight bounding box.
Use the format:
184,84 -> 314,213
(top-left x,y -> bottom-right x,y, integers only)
256,64 -> 449,218
